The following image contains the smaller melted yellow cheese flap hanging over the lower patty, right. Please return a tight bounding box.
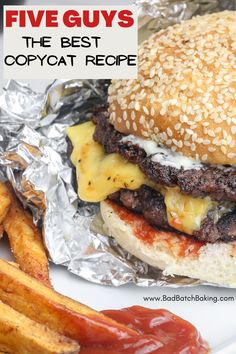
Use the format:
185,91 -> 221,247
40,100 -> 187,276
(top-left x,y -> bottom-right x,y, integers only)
165,188 -> 213,235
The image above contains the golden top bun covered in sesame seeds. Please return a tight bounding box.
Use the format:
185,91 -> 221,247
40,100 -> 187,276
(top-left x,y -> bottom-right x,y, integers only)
108,11 -> 236,165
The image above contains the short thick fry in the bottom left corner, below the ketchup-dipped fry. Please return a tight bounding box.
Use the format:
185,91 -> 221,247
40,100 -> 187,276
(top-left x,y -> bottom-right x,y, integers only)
0,301 -> 80,354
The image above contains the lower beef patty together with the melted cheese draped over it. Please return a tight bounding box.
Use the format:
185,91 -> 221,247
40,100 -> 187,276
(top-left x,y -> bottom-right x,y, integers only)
109,186 -> 236,242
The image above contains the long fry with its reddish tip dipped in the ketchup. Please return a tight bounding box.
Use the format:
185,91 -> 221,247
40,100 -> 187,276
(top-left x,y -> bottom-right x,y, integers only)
0,259 -> 137,345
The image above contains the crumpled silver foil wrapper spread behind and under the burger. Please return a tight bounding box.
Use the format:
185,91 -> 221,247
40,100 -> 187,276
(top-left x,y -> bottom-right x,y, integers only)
0,0 -> 232,287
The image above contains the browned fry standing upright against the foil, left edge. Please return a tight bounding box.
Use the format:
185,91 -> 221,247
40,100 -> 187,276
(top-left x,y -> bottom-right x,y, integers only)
3,187 -> 51,287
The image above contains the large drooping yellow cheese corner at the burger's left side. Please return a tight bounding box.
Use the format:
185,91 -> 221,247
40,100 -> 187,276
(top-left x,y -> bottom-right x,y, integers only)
67,122 -> 146,202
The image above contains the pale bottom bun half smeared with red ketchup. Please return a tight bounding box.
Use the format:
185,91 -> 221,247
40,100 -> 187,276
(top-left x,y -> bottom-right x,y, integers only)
101,200 -> 236,287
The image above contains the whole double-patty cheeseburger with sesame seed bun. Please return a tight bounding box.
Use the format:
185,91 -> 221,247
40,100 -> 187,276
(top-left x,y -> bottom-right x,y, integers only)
68,12 -> 236,286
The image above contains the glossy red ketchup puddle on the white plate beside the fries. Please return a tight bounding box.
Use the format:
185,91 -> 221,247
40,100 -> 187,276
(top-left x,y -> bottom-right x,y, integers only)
80,306 -> 209,354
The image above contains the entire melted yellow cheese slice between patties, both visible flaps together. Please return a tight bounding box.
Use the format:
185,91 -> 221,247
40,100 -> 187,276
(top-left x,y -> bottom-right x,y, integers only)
67,122 -> 216,235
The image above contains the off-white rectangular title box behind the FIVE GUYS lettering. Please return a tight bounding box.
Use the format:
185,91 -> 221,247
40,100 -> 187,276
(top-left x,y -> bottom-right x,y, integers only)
4,5 -> 137,80
